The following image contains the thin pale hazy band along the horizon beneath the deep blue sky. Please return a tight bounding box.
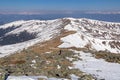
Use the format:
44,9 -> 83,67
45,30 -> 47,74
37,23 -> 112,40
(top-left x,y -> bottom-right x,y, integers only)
0,10 -> 120,15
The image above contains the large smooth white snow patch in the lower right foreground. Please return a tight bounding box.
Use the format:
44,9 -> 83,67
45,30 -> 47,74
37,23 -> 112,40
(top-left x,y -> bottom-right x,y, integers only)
73,51 -> 120,80
